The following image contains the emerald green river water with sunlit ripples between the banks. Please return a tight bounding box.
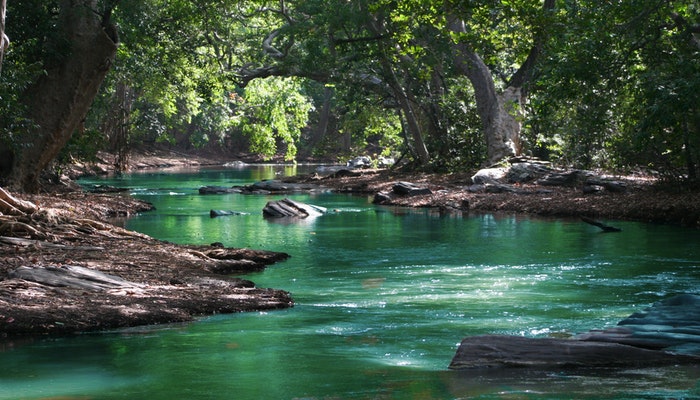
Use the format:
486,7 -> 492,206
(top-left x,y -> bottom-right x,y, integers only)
0,166 -> 700,400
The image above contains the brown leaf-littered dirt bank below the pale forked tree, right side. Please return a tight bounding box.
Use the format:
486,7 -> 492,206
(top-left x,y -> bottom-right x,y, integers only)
301,170 -> 700,228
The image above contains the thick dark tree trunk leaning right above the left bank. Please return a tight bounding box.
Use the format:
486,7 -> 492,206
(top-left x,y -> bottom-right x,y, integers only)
10,0 -> 118,192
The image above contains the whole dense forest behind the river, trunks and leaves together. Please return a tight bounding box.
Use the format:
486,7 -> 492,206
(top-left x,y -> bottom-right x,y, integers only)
0,0 -> 700,192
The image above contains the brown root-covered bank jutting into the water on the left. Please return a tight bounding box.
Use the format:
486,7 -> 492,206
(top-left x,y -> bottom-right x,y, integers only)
0,185 -> 293,337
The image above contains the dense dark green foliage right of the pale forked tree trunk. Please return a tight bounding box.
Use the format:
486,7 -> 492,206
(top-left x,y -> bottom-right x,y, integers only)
529,0 -> 700,178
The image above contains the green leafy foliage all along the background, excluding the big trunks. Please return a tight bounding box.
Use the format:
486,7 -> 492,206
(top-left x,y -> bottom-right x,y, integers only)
0,0 -> 700,178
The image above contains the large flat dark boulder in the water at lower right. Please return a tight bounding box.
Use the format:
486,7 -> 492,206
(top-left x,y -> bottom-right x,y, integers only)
450,294 -> 700,369
